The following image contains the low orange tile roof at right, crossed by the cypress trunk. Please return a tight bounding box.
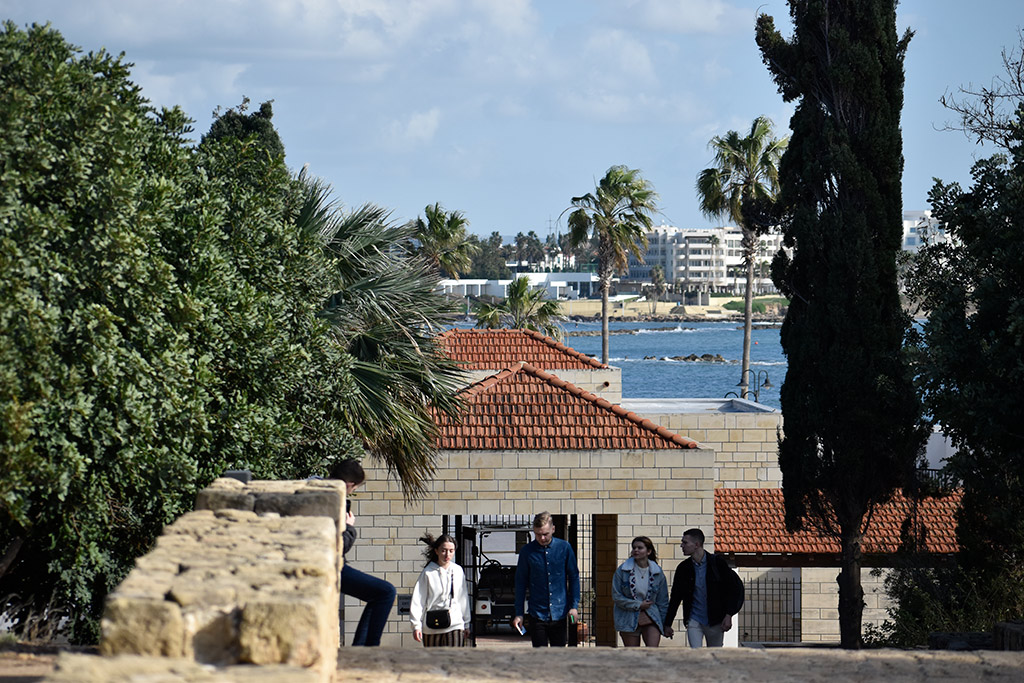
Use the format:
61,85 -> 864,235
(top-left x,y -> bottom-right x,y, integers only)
715,488 -> 962,555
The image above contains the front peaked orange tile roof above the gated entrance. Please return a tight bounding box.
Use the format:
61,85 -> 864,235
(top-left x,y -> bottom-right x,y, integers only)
437,362 -> 697,451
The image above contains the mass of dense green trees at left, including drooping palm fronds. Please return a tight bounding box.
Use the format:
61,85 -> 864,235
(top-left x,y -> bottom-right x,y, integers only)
0,24 -> 466,640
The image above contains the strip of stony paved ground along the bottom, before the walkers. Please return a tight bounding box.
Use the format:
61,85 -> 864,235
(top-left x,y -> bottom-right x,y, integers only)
6,643 -> 1024,683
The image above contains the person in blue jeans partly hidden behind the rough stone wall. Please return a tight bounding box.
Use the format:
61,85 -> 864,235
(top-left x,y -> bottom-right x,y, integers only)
330,460 -> 395,646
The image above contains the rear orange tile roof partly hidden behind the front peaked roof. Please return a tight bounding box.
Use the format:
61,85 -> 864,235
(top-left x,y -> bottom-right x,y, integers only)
438,330 -> 608,371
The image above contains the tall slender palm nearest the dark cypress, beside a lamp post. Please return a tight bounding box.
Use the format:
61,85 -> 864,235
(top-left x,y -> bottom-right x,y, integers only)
696,116 -> 790,397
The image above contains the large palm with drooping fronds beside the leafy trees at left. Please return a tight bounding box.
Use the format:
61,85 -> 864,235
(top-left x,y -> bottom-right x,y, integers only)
294,173 -> 461,498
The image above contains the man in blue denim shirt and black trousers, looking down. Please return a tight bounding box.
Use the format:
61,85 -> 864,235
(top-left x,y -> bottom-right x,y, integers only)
512,512 -> 580,647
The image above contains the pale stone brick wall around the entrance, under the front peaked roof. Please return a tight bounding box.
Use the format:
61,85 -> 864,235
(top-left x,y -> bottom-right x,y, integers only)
345,449 -> 715,647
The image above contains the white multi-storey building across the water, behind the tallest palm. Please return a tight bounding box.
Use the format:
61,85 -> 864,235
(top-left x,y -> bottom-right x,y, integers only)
629,225 -> 782,294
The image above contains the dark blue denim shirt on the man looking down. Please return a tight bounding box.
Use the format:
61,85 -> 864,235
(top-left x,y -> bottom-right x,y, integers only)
515,539 -> 580,622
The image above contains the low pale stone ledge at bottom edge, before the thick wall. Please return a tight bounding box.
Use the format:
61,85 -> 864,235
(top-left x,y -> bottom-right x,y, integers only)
43,652 -> 321,683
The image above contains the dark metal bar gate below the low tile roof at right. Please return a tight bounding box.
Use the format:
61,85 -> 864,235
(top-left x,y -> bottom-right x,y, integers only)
740,578 -> 801,643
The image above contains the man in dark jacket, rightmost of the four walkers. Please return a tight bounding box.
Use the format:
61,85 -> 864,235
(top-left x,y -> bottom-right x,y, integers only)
665,528 -> 743,647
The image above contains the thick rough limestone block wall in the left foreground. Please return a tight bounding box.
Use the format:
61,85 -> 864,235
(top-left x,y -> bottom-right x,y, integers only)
76,479 -> 345,681
